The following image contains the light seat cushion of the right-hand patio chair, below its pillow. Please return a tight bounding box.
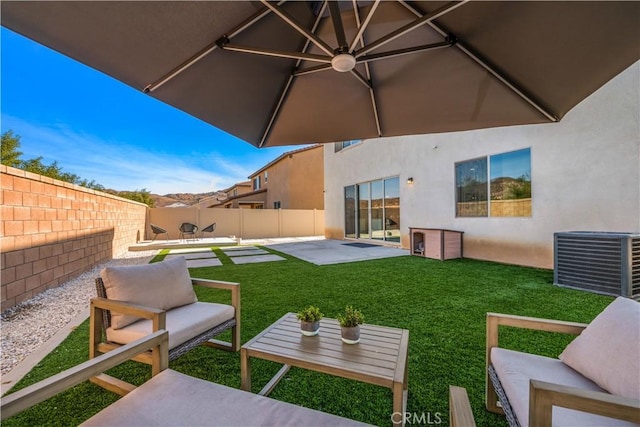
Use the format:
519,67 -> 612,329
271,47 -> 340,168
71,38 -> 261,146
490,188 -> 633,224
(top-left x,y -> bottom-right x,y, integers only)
491,347 -> 636,427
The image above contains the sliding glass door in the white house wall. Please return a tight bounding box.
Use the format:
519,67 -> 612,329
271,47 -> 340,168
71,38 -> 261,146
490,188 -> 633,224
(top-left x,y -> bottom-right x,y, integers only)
344,176 -> 400,243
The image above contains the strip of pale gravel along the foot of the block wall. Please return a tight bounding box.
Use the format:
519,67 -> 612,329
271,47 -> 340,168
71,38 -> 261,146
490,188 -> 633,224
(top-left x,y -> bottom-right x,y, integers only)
0,250 -> 157,375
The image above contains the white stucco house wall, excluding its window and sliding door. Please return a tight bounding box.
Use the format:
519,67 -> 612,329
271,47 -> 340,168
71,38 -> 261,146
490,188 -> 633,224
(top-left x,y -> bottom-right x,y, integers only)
325,63 -> 640,268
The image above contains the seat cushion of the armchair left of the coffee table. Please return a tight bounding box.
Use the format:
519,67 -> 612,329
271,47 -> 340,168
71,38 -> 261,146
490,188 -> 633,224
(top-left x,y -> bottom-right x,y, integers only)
107,302 -> 235,349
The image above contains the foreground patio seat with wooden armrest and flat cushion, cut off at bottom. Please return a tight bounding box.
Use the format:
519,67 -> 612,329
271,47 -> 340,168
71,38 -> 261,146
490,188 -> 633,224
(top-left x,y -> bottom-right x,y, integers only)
0,330 -> 366,426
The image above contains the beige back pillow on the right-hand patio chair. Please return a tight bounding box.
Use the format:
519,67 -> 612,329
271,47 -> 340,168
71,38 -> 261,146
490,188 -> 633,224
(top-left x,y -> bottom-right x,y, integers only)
560,297 -> 640,399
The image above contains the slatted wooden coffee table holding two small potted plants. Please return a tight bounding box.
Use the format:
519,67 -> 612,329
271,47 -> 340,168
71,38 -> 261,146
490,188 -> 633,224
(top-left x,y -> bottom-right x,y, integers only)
240,313 -> 409,424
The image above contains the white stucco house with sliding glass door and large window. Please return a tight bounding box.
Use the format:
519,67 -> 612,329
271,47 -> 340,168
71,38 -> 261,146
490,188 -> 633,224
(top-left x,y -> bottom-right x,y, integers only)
324,63 -> 640,270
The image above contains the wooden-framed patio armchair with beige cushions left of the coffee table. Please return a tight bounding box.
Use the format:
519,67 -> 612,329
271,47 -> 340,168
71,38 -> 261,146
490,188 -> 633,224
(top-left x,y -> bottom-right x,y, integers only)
89,257 -> 240,394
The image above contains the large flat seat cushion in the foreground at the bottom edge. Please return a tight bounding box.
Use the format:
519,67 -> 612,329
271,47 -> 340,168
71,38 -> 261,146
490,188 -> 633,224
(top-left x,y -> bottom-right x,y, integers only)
82,369 -> 366,427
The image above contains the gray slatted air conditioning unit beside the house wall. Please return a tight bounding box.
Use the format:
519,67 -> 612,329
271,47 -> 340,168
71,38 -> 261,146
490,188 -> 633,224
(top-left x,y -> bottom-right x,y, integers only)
553,231 -> 640,299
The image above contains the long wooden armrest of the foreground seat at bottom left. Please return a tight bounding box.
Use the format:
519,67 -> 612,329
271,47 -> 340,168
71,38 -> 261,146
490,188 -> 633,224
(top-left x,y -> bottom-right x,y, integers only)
0,330 -> 169,420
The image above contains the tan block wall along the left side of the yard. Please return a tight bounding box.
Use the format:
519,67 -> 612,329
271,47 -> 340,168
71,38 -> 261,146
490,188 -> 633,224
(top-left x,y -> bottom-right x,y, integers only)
0,165 -> 147,311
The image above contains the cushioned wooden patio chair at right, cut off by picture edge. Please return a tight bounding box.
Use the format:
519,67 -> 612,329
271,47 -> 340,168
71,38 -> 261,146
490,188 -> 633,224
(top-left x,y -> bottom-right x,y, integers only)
486,297 -> 640,427
